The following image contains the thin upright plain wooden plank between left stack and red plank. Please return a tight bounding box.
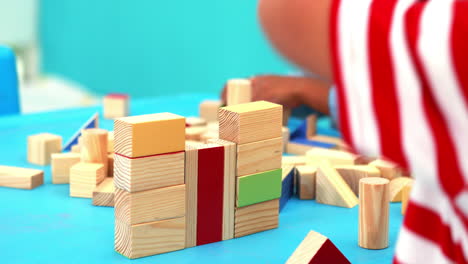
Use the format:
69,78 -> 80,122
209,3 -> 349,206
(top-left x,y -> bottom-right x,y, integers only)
185,143 -> 200,248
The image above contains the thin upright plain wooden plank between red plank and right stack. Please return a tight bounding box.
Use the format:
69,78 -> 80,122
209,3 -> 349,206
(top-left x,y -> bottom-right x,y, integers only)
208,139 -> 237,240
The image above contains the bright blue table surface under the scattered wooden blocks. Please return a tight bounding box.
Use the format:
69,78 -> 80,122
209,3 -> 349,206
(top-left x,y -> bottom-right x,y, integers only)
0,94 -> 402,264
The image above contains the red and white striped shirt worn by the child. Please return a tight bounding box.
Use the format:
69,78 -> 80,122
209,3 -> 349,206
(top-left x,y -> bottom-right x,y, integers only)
331,0 -> 468,263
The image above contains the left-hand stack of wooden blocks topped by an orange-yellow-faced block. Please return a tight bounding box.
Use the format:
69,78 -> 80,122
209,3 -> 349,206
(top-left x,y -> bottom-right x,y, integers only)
114,113 -> 186,258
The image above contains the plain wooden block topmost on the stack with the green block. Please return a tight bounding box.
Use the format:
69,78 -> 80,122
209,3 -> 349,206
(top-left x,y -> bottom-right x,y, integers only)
219,101 -> 283,144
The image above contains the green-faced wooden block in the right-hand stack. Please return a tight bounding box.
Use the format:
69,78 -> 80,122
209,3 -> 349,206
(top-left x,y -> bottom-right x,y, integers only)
236,169 -> 282,207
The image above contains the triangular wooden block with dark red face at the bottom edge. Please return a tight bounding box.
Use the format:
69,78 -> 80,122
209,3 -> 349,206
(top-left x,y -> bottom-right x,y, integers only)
286,231 -> 351,264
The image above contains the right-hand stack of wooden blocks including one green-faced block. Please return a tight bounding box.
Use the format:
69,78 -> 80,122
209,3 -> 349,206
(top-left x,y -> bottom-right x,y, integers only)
219,101 -> 283,237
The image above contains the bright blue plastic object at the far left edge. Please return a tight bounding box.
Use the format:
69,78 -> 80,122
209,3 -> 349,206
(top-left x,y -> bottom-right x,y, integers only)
0,45 -> 20,115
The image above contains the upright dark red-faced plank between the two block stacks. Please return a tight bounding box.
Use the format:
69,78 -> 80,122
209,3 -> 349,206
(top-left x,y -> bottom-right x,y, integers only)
197,144 -> 224,246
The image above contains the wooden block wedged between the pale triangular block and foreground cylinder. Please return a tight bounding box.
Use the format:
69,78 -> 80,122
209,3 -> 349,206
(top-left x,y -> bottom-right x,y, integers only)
335,165 -> 381,196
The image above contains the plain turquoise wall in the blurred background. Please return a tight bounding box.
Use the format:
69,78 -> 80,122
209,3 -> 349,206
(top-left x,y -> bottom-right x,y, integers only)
39,0 -> 292,97
